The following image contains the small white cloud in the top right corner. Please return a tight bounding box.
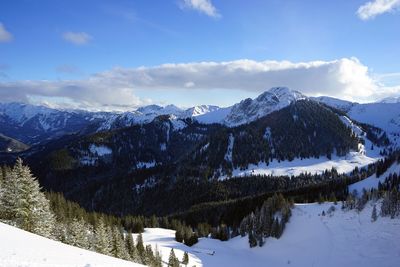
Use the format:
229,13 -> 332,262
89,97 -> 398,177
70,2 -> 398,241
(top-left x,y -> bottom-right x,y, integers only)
357,0 -> 400,20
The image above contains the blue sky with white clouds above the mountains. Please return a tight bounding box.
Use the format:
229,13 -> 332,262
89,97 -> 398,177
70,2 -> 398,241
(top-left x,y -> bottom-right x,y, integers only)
0,0 -> 400,110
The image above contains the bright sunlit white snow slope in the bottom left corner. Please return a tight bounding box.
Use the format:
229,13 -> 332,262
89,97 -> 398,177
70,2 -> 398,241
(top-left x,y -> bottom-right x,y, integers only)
0,223 -> 143,267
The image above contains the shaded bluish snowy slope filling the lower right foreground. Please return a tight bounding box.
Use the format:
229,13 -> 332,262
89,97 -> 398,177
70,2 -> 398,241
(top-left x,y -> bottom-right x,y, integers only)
137,203 -> 400,267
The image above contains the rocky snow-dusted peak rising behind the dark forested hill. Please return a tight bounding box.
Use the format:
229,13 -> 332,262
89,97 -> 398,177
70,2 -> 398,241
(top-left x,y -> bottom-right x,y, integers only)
196,87 -> 307,126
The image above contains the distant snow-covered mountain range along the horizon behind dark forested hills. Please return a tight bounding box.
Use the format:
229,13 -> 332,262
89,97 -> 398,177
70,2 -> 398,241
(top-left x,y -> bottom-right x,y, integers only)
0,87 -> 400,150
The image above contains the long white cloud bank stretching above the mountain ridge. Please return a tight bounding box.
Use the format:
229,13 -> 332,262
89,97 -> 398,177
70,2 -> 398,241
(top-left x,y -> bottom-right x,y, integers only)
0,58 -> 400,110
